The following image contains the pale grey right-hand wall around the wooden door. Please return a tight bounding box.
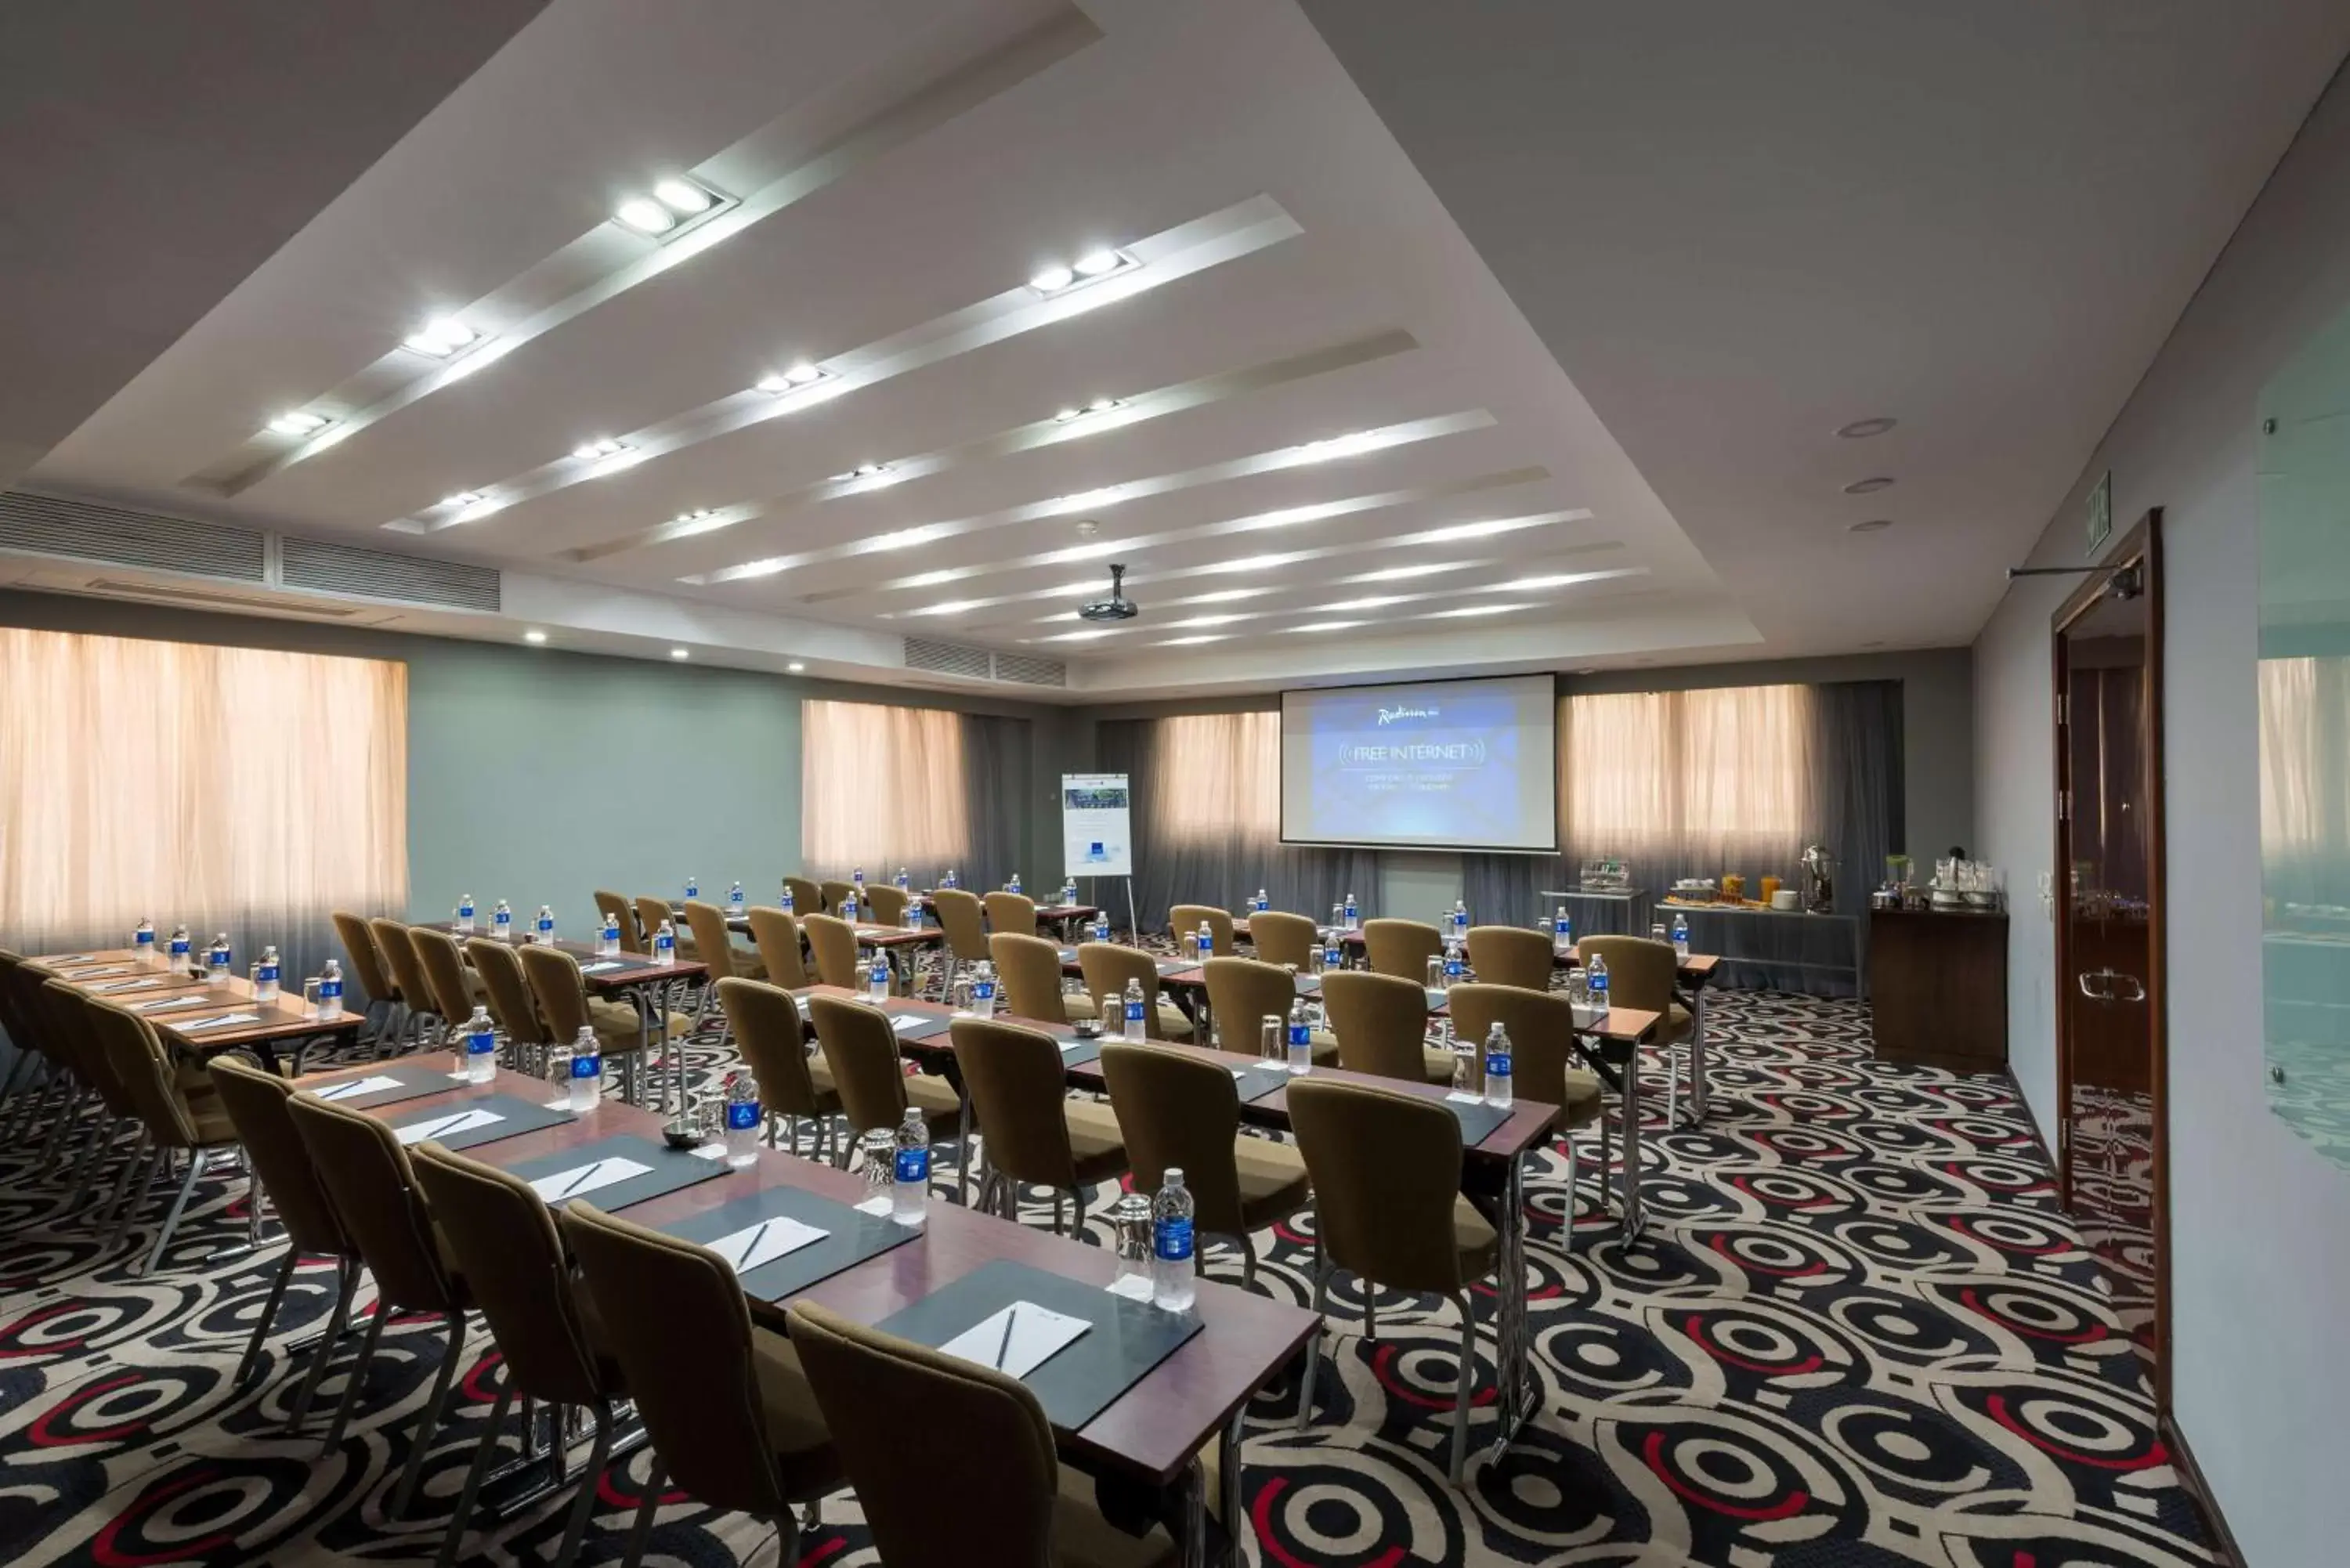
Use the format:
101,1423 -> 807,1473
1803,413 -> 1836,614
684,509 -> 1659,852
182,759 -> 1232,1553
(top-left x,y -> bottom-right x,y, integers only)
1974,55 -> 2350,1568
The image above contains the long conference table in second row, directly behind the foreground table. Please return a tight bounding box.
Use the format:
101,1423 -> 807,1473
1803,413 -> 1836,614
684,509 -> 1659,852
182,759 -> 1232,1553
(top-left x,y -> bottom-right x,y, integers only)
792,985 -> 1579,1466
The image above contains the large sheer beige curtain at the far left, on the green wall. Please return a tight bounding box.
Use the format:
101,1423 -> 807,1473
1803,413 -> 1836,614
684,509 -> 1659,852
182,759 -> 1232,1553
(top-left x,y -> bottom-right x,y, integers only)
0,630 -> 409,974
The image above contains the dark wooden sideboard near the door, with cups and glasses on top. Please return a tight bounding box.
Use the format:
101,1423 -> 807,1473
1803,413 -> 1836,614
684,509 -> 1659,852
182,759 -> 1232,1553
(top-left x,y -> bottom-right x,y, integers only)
1868,910 -> 2007,1072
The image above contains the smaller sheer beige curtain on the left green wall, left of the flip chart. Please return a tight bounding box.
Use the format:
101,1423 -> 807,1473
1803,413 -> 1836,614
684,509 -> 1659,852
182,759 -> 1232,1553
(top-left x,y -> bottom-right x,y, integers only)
799,698 -> 964,887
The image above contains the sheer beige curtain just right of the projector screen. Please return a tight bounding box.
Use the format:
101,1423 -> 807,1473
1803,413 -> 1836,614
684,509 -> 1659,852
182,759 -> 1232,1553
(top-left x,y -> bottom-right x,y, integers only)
1558,686 -> 1826,875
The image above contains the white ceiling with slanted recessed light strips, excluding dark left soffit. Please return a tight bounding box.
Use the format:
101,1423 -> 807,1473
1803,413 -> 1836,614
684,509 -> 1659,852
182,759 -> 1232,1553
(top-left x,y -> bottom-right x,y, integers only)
0,0 -> 2345,698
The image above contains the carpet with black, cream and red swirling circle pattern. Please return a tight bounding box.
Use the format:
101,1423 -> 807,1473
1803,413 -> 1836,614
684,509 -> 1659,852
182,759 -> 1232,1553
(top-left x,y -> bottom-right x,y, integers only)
0,992 -> 2214,1568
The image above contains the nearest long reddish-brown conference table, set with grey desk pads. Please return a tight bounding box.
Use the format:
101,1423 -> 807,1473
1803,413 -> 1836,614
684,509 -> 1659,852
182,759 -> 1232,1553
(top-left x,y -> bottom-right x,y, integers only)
298,1062 -> 1321,1566
